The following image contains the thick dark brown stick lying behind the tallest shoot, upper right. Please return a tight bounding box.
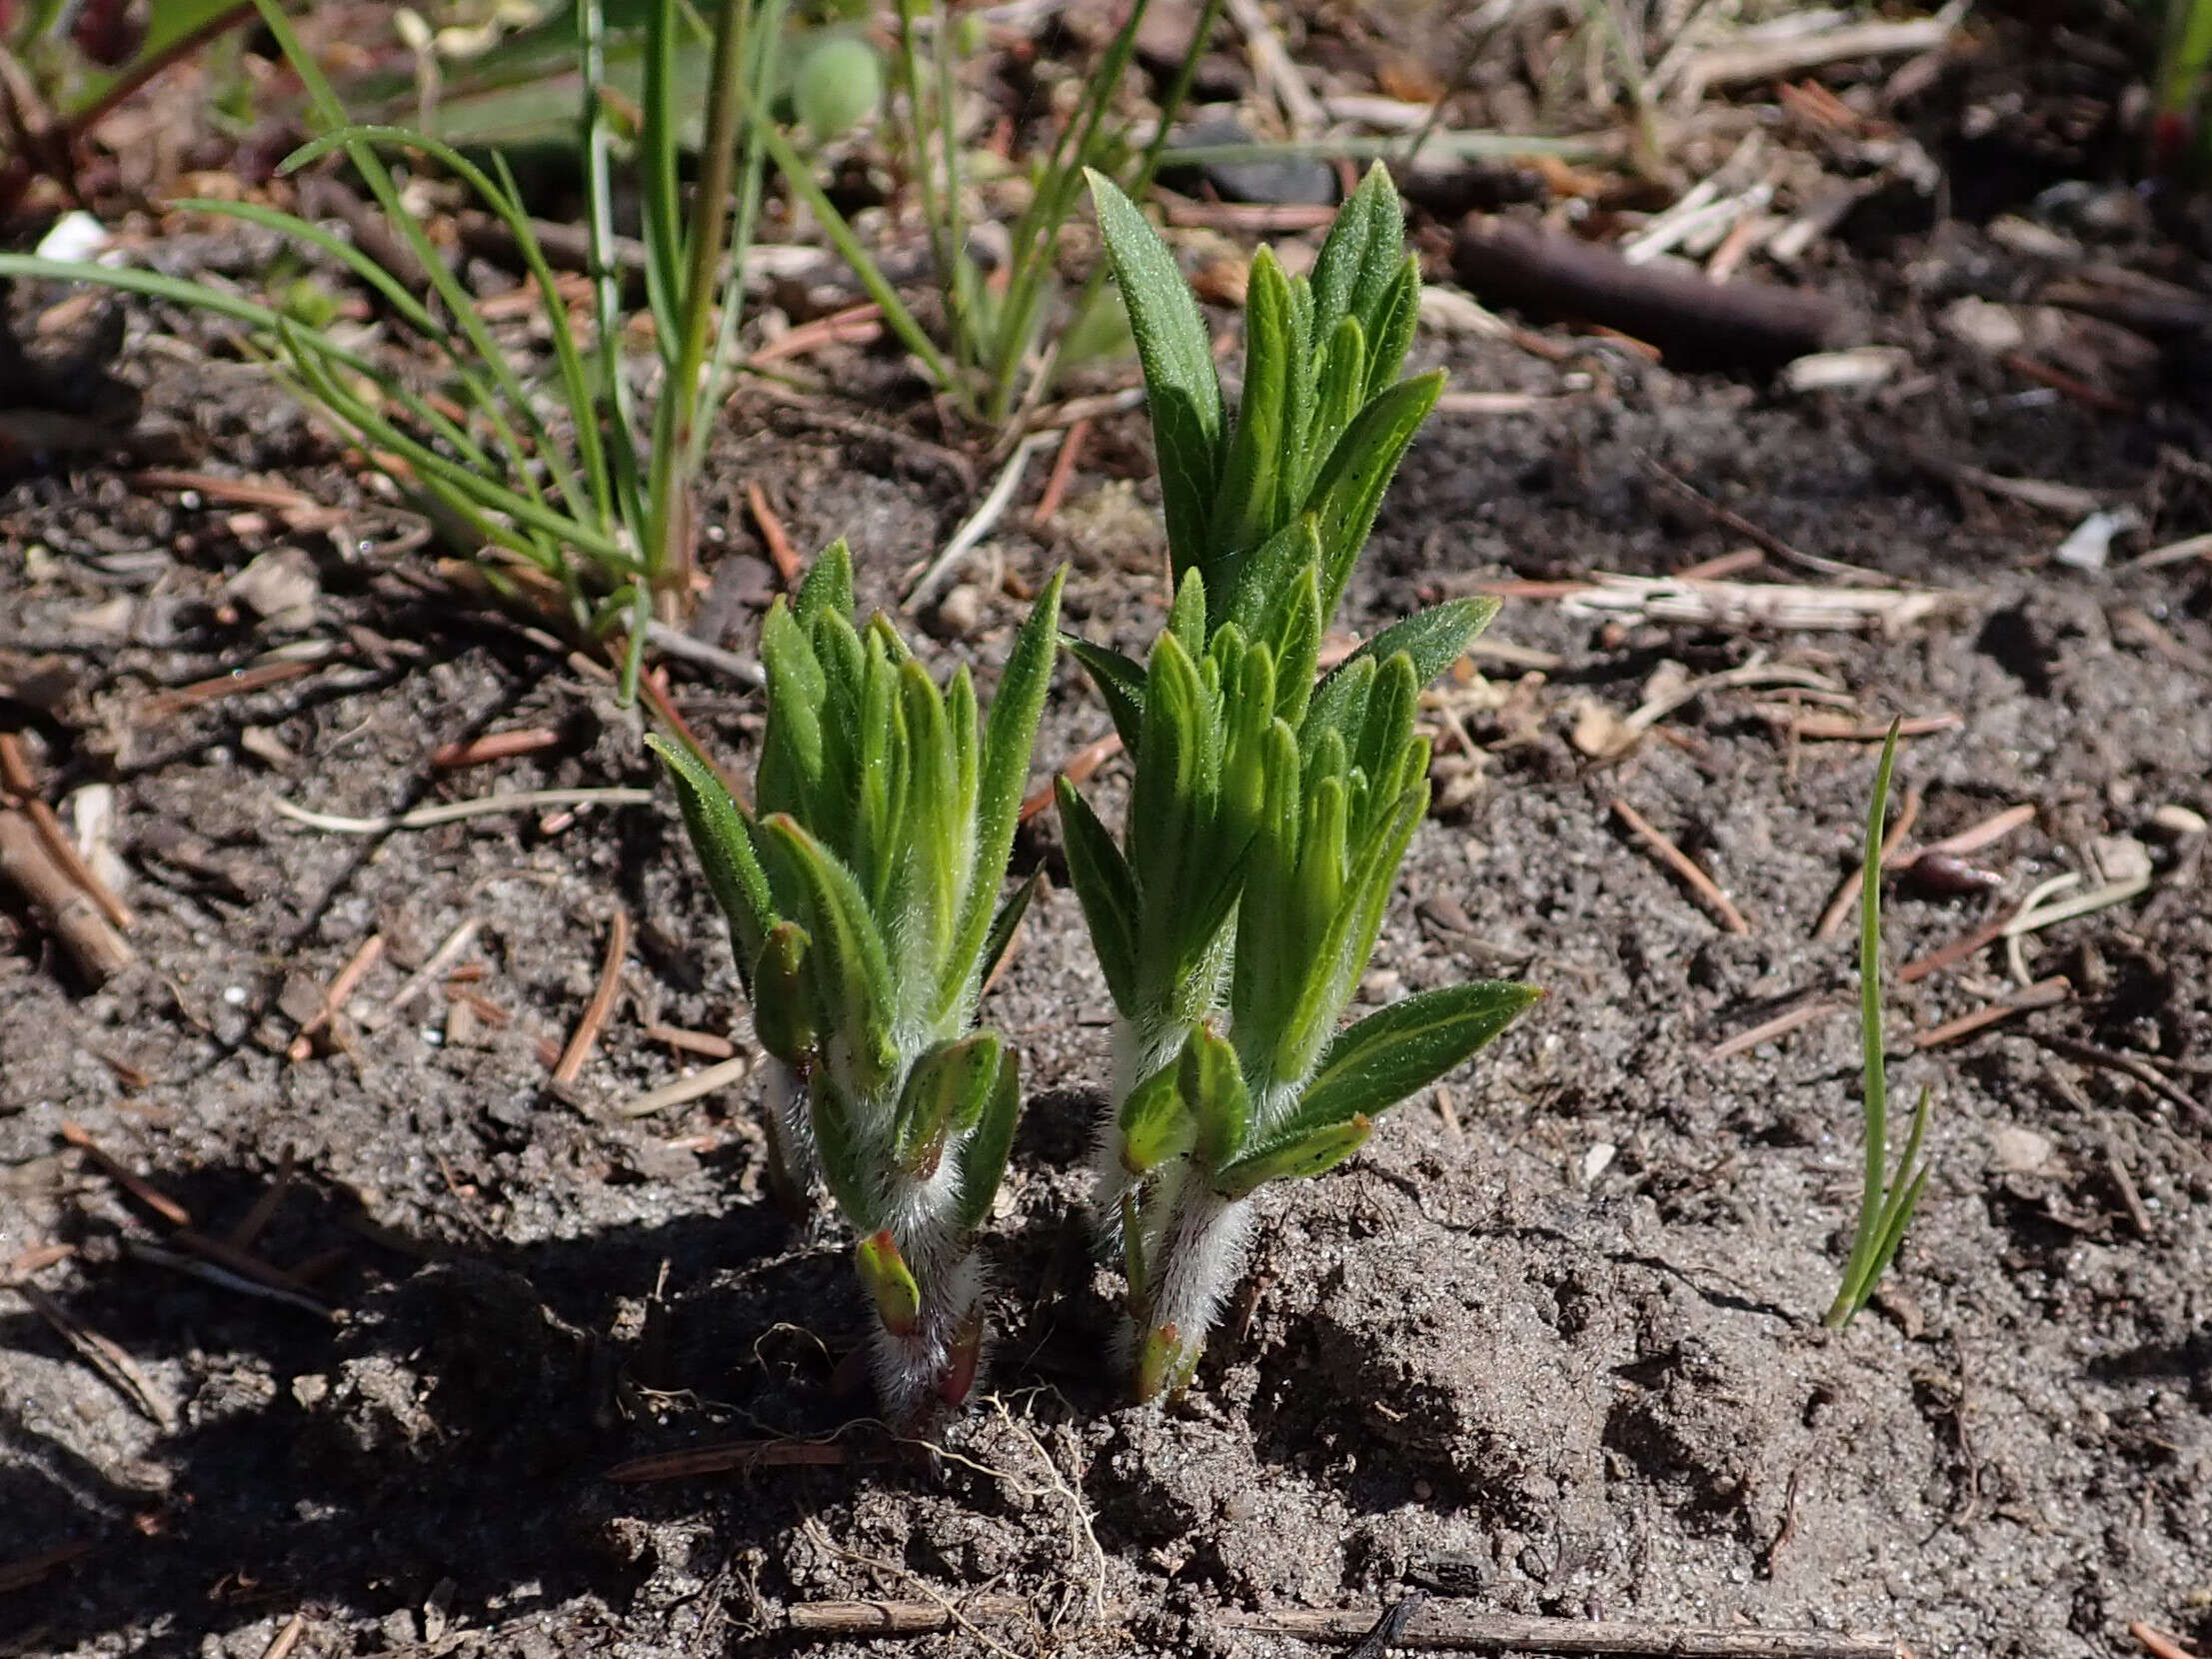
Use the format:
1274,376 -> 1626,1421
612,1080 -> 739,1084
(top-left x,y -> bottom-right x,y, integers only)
1451,215 -> 1842,370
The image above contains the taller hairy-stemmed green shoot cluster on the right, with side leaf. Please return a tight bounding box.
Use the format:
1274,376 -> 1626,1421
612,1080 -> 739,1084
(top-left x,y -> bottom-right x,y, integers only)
1058,168 -> 1539,1398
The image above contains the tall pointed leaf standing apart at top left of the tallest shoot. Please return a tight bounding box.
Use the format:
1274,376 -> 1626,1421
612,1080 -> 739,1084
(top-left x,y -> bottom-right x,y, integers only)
1087,168 -> 1223,573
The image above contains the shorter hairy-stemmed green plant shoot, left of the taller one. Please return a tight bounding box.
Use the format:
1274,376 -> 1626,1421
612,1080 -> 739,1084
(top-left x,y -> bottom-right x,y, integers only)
651,542 -> 1060,1416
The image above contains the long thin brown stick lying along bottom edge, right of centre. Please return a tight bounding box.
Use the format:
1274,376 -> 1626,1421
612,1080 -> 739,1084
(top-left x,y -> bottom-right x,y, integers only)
1214,1601 -> 1904,1659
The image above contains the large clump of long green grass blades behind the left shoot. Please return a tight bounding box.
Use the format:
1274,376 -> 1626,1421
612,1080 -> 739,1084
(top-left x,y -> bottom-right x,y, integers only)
0,0 -> 783,693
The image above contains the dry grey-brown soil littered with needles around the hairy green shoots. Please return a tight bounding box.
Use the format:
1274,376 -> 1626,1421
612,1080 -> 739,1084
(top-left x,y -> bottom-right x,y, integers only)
0,188 -> 2212,1659
